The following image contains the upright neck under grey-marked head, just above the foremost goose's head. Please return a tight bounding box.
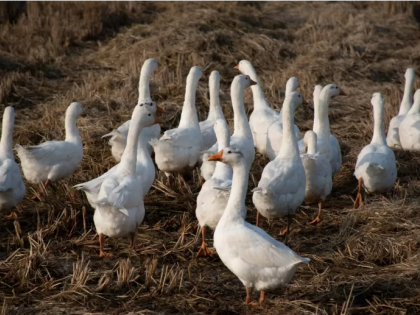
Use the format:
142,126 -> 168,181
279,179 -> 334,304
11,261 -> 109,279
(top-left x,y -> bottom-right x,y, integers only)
231,80 -> 252,139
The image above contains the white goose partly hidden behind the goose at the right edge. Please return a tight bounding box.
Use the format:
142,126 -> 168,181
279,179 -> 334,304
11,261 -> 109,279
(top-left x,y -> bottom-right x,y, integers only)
386,68 -> 416,149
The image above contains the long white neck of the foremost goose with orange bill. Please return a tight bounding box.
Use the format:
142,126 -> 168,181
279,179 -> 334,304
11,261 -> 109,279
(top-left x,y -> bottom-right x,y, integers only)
219,163 -> 250,226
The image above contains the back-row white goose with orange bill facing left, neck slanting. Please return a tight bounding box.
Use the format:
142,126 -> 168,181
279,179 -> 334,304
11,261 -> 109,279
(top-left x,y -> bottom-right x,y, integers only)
235,60 -> 279,155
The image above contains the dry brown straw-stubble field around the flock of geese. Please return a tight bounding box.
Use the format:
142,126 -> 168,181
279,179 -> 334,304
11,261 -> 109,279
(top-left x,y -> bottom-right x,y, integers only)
0,2 -> 420,315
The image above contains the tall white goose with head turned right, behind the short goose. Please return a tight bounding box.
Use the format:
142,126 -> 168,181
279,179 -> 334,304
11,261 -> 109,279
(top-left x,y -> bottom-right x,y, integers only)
299,84 -> 347,176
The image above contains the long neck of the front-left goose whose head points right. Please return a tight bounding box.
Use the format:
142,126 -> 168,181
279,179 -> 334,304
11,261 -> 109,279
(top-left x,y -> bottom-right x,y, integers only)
118,106 -> 146,174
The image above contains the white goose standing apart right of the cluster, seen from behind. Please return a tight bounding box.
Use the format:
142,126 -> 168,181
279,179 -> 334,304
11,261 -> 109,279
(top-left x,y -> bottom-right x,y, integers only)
354,93 -> 397,208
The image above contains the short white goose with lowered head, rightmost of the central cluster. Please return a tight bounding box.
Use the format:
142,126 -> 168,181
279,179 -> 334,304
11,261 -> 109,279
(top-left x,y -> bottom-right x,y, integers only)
300,130 -> 332,224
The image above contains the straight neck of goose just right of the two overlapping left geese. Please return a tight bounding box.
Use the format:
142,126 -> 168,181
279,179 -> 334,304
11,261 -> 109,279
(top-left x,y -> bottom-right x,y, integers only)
178,74 -> 200,128
